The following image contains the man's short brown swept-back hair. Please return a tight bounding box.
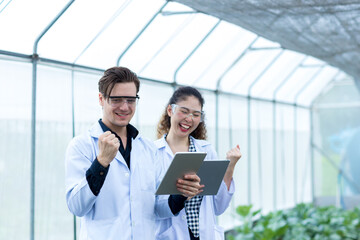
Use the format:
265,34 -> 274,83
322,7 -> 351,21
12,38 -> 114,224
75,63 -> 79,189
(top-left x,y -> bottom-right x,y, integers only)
99,67 -> 140,98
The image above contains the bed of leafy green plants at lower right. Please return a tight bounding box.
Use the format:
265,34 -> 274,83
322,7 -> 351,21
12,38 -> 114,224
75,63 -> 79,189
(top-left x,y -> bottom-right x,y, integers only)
227,204 -> 360,240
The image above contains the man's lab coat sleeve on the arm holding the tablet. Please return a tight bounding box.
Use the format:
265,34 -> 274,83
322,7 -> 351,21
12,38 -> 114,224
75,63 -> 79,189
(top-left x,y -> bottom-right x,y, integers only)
155,151 -> 174,219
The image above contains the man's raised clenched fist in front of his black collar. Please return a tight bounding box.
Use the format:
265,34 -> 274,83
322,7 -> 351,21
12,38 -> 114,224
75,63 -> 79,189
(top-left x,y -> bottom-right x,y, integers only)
97,131 -> 120,167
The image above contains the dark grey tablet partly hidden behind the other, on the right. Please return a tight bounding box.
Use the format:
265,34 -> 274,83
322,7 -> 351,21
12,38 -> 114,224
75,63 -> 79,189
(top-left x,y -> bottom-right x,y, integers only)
197,160 -> 230,195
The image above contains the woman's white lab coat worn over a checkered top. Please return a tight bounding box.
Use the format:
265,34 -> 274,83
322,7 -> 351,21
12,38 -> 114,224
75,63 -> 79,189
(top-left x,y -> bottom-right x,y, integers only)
155,137 -> 235,240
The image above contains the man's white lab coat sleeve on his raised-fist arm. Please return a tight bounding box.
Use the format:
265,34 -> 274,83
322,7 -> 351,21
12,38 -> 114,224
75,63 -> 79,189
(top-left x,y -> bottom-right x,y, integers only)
65,137 -> 96,217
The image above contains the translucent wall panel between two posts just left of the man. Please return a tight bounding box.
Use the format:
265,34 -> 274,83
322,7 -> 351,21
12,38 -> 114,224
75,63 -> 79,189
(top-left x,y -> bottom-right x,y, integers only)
35,66 -> 73,240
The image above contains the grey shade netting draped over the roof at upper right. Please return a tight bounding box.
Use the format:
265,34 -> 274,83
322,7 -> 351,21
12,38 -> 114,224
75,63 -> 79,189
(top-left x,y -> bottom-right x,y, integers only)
176,0 -> 360,83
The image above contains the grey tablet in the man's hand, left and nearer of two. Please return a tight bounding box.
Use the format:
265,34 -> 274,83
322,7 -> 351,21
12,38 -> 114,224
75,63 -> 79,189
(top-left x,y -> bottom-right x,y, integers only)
155,152 -> 206,195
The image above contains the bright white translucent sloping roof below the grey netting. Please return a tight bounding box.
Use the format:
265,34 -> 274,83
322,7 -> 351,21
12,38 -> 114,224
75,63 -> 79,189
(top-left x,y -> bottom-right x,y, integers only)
0,0 -> 354,103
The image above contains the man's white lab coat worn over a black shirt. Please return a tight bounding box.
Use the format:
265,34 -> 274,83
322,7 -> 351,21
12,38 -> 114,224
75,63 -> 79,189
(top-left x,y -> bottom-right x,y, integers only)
65,123 -> 173,240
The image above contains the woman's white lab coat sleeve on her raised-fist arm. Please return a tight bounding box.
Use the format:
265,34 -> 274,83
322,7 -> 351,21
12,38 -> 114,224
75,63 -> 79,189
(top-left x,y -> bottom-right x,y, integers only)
208,147 -> 235,216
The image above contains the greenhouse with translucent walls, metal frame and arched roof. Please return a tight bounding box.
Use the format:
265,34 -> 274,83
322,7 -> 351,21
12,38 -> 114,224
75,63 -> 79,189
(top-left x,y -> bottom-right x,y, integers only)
0,0 -> 360,240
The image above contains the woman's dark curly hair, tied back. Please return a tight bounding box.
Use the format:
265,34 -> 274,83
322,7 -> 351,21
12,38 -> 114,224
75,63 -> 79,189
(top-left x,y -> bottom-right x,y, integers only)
157,87 -> 207,139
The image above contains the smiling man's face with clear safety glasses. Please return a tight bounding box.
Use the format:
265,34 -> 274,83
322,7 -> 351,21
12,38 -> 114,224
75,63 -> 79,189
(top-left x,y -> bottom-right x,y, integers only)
99,82 -> 136,132
